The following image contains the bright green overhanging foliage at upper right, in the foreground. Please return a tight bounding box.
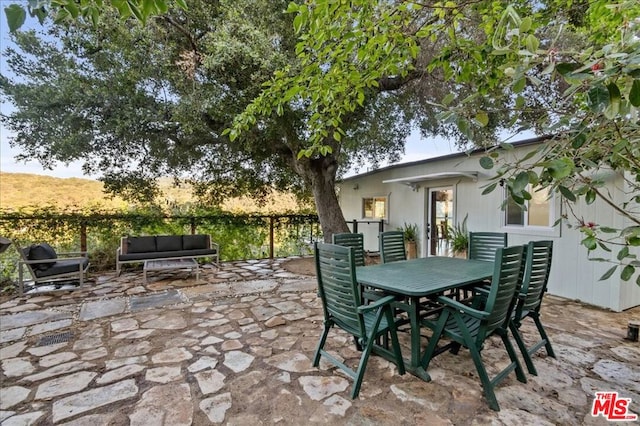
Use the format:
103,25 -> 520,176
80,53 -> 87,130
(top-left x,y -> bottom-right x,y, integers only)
230,0 -> 640,285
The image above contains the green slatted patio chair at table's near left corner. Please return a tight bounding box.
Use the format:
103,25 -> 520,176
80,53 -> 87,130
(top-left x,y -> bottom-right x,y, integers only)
313,243 -> 405,398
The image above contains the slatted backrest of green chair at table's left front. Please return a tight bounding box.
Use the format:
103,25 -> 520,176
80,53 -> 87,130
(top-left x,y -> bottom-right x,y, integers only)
315,243 -> 366,337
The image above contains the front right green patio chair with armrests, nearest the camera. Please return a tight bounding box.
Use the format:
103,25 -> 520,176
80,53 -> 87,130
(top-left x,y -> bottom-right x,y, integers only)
422,246 -> 527,411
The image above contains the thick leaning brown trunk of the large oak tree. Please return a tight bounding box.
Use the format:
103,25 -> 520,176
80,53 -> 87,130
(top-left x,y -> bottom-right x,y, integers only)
306,156 -> 349,242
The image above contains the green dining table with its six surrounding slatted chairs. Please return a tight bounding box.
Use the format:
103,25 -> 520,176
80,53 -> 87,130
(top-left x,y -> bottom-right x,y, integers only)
314,231 -> 555,411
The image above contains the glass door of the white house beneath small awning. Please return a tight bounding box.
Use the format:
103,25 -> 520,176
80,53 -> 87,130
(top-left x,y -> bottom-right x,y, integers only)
427,186 -> 454,256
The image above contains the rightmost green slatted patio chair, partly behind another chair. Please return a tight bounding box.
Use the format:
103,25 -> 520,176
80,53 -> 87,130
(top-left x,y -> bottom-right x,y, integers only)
509,241 -> 556,376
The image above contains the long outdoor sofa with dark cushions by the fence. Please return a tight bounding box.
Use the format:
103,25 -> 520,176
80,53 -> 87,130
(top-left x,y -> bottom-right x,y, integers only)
116,234 -> 220,275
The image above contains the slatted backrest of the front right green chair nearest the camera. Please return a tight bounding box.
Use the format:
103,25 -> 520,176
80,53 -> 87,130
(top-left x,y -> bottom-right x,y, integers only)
478,246 -> 523,342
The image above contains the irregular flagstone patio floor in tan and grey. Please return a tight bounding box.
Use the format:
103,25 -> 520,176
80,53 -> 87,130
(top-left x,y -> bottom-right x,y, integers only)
0,259 -> 640,426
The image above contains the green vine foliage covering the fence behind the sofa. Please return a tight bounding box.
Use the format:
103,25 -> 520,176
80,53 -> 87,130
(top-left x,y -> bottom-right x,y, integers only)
0,208 -> 321,288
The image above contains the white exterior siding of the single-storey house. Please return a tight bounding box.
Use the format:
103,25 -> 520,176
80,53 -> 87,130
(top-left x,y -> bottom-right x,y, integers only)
340,141 -> 640,311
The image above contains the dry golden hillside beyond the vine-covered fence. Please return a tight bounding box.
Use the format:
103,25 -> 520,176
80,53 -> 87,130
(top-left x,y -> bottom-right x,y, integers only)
0,172 -> 308,214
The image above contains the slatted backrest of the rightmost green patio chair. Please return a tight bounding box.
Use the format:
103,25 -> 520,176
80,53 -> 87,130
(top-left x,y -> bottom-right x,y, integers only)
519,241 -> 553,311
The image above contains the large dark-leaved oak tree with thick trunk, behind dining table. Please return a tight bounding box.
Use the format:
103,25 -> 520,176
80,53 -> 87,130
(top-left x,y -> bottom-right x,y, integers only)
0,1 -> 500,239
